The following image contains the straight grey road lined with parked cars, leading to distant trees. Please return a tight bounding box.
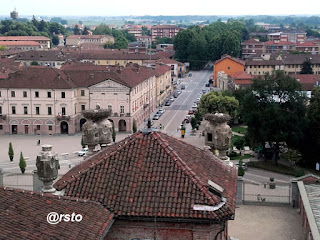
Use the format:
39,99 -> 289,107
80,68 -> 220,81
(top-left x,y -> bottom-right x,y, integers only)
139,70 -> 212,137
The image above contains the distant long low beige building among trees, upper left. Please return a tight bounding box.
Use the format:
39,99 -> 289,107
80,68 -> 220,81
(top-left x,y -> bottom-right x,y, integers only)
66,35 -> 114,46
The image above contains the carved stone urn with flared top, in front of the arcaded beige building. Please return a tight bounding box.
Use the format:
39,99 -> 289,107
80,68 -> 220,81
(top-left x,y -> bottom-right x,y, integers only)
82,106 -> 113,158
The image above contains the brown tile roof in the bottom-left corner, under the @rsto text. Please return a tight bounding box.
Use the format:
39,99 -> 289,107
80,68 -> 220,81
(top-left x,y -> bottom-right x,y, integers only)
0,187 -> 114,240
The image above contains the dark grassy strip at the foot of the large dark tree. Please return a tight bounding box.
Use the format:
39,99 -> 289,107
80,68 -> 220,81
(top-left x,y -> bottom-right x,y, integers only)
247,161 -> 305,177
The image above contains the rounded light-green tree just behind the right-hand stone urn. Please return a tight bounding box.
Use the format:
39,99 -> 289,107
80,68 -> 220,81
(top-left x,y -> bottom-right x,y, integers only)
199,91 -> 239,117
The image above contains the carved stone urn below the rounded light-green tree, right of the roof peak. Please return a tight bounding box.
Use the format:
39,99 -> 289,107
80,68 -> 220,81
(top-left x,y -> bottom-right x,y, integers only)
205,113 -> 232,160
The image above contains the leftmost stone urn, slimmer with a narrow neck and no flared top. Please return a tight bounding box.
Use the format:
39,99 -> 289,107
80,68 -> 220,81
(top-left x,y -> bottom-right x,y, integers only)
36,145 -> 60,193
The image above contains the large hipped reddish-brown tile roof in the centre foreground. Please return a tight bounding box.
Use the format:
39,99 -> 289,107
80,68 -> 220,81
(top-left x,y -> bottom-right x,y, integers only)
55,132 -> 237,221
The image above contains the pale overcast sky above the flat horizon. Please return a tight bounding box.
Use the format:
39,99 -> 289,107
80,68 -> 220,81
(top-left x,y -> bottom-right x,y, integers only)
0,0 -> 320,16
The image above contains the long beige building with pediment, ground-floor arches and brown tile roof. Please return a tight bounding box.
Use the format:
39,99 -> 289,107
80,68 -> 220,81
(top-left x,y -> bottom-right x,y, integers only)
0,64 -> 172,135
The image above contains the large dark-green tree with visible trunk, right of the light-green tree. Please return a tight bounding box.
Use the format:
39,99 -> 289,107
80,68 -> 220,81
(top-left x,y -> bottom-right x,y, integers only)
241,71 -> 306,164
